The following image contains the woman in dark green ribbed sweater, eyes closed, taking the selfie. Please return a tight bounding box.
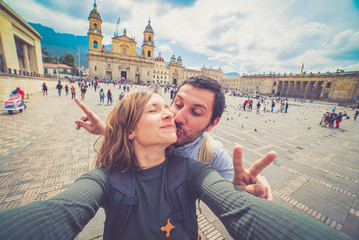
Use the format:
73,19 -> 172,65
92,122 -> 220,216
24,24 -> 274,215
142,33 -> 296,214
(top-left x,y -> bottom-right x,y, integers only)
0,92 -> 345,240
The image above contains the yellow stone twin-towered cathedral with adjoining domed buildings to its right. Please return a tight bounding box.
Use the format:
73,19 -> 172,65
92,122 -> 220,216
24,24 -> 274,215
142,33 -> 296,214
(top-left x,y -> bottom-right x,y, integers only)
87,3 -> 223,85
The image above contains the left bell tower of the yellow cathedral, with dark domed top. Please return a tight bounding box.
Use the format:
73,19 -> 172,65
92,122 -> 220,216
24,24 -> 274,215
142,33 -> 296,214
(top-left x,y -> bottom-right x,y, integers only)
87,0 -> 103,51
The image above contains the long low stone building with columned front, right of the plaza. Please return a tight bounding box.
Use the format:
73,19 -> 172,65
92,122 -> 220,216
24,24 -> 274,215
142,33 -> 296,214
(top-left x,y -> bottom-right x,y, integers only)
220,71 -> 359,102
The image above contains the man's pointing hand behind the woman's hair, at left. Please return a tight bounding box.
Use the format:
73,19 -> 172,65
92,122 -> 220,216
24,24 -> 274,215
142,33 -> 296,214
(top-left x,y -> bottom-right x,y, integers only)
75,98 -> 106,135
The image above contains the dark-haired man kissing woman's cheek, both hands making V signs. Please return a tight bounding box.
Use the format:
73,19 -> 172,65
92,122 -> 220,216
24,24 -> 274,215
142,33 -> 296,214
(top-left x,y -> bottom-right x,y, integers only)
75,75 -> 277,200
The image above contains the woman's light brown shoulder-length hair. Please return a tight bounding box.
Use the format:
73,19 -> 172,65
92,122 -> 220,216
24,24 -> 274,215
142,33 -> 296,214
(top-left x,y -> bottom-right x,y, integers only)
96,91 -> 153,171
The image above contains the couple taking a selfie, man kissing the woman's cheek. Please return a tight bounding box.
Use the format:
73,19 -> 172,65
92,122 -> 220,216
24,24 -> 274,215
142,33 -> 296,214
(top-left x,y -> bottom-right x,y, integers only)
0,76 -> 354,240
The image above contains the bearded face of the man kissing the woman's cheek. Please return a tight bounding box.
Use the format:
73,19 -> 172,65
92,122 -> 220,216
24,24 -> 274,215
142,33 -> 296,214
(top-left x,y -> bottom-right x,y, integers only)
171,84 -> 219,147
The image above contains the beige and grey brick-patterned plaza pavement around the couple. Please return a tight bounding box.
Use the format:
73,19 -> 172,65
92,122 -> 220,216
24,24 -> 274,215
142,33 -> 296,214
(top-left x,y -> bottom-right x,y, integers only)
0,81 -> 359,240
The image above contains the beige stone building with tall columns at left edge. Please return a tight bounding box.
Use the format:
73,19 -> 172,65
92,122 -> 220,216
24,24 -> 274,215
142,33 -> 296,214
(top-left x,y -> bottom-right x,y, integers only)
0,0 -> 44,76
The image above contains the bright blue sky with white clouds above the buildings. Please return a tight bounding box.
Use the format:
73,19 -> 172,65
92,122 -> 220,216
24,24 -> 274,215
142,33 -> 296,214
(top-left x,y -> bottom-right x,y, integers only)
4,0 -> 359,74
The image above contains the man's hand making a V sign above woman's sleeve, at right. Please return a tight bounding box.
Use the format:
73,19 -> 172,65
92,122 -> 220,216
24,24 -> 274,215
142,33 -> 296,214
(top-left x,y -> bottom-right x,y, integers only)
232,146 -> 277,200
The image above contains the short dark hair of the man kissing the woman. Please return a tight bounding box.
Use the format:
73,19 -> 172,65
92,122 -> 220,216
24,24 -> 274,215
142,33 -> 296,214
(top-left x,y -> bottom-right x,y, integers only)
177,75 -> 226,124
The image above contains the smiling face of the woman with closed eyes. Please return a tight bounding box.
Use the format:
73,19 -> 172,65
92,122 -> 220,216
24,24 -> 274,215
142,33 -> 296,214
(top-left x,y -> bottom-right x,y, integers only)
129,94 -> 177,147
